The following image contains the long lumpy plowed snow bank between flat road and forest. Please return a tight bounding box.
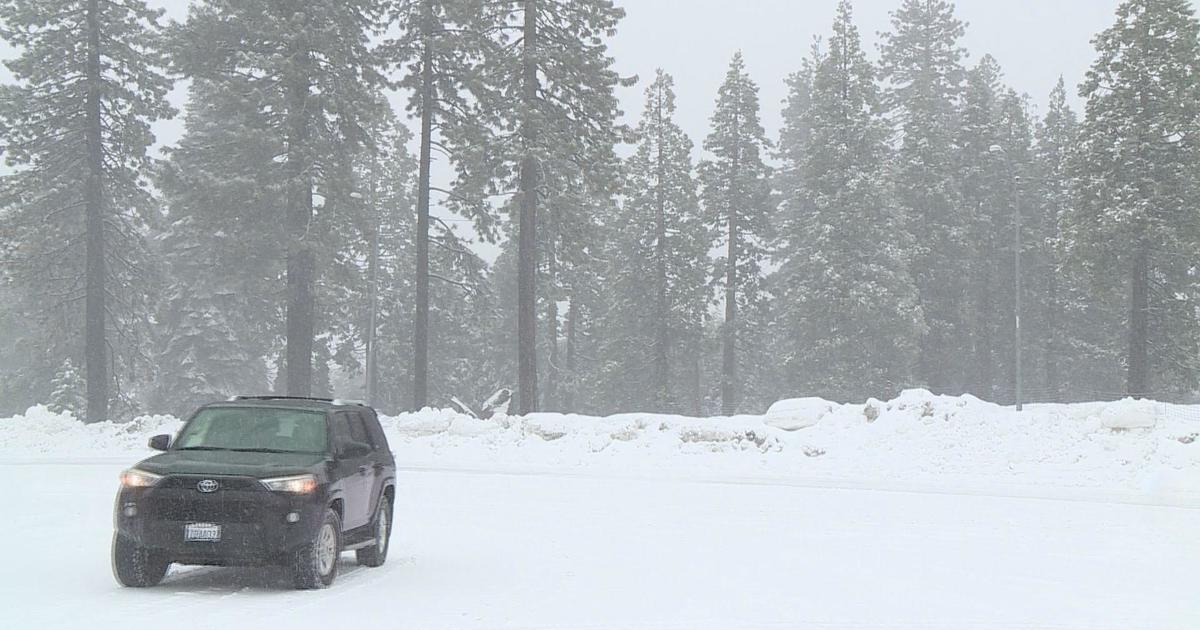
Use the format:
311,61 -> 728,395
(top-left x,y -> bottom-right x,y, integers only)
0,390 -> 1200,496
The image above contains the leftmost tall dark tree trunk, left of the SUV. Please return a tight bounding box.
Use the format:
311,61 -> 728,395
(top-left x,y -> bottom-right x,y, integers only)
84,0 -> 108,422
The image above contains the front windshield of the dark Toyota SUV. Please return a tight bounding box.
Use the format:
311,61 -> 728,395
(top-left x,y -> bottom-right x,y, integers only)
175,407 -> 328,452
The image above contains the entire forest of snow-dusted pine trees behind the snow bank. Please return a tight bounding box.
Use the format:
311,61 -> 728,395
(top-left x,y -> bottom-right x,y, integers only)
0,0 -> 1200,422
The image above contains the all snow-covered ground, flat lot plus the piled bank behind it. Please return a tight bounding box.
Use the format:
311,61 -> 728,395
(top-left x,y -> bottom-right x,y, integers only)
0,391 -> 1200,630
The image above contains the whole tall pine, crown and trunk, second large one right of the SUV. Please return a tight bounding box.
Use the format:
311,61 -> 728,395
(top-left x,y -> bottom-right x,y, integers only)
461,0 -> 629,413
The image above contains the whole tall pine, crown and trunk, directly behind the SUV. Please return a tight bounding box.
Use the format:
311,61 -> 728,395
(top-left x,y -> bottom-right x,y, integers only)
176,0 -> 385,395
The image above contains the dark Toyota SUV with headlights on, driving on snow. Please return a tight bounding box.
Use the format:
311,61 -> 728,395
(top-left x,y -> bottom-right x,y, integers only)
113,396 -> 396,588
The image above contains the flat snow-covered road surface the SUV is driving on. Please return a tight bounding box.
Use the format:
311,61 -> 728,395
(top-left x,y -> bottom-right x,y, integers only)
0,462 -> 1200,630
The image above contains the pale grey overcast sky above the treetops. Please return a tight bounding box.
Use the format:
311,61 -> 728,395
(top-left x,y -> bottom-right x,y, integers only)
0,0 -> 1195,255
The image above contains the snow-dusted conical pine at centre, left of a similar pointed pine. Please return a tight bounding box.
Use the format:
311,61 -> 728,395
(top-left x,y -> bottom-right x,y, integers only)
600,70 -> 712,412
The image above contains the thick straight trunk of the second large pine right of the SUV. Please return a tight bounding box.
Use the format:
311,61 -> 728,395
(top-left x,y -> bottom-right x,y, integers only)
517,0 -> 538,414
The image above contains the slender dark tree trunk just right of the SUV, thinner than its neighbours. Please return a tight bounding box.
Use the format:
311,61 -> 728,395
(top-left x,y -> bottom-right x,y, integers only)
413,0 -> 437,410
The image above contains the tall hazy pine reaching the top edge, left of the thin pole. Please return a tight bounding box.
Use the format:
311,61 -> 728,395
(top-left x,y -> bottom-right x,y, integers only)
881,0 -> 970,391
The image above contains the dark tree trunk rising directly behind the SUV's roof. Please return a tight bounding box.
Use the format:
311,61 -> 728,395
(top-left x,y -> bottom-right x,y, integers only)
286,42 -> 317,396
